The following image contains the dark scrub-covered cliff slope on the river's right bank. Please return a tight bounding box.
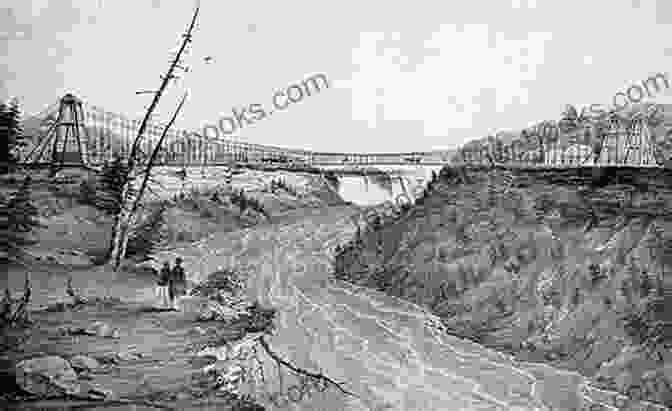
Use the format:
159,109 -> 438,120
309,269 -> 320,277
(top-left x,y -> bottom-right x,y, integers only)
336,166 -> 672,406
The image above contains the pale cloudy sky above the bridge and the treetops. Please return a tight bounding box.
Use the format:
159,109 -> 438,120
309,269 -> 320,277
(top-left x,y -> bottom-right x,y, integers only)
0,0 -> 672,153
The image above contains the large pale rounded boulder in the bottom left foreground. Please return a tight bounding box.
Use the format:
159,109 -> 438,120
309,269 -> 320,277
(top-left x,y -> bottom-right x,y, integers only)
16,356 -> 81,398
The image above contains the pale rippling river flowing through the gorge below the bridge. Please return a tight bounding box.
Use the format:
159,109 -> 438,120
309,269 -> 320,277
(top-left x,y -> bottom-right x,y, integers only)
148,207 -> 620,411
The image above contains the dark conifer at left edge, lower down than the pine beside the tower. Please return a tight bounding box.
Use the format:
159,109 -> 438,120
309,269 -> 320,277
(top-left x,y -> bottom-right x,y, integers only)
0,177 -> 42,260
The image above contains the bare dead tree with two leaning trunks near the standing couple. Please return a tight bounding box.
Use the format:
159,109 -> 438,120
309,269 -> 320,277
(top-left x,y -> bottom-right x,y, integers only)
110,7 -> 199,271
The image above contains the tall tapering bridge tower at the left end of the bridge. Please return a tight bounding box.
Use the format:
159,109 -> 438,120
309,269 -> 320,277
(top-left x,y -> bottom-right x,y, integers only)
25,93 -> 89,174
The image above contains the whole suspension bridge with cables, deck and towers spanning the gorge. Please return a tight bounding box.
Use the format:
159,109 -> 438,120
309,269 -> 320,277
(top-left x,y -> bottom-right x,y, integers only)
15,94 -> 662,174
